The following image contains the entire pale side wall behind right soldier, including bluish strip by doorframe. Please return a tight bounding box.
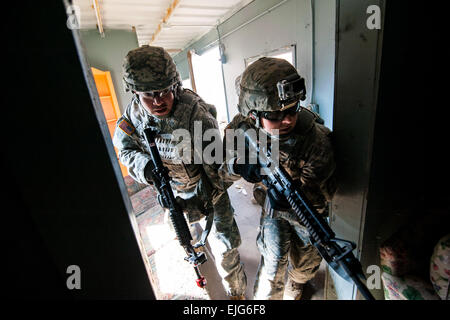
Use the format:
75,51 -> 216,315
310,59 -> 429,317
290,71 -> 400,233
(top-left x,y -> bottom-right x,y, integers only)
174,0 -> 336,128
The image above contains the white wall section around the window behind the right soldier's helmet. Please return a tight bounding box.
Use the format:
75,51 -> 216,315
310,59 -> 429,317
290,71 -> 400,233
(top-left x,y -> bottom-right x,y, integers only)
222,0 -> 312,118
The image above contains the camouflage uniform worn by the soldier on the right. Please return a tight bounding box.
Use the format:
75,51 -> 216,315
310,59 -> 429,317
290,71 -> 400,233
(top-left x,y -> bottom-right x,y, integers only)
219,56 -> 336,300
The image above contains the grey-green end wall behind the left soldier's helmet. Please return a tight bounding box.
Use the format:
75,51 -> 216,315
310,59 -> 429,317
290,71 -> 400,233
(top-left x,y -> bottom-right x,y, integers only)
80,30 -> 138,112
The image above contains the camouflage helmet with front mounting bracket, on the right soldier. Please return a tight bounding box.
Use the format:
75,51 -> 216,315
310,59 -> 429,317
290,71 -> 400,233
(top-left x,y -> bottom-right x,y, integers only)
235,57 -> 306,117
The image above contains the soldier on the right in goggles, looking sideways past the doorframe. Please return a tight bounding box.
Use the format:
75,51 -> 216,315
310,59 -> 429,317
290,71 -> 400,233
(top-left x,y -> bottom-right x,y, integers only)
219,57 -> 336,300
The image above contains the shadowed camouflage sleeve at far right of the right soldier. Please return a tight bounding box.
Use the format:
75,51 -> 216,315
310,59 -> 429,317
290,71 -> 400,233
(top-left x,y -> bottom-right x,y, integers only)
300,124 -> 336,212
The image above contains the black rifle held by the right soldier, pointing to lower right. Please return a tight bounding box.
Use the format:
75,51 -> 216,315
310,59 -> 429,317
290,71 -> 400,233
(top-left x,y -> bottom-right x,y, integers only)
239,123 -> 375,300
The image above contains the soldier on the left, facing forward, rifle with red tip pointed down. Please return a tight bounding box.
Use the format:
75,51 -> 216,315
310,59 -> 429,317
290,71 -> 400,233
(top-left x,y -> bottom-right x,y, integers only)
113,46 -> 246,299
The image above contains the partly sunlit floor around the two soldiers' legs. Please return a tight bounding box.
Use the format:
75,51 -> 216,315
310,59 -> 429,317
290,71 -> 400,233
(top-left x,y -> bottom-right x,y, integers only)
137,179 -> 326,300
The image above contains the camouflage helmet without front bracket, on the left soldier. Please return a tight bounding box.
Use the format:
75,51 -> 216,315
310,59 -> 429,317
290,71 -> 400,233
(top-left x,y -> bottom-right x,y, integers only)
122,45 -> 181,92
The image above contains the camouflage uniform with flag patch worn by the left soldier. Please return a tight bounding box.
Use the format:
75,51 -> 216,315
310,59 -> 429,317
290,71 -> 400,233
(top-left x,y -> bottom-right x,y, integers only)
113,47 -> 246,296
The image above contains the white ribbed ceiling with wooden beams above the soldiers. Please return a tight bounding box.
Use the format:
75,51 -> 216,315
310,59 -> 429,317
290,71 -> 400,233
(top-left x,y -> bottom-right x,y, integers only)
73,0 -> 253,54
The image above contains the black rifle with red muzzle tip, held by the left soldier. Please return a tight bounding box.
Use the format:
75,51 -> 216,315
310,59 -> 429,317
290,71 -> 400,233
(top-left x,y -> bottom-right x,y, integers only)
144,128 -> 207,288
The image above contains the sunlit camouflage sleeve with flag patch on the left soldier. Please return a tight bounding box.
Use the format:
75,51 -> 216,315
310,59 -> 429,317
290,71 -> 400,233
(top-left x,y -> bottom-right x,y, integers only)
113,115 -> 151,184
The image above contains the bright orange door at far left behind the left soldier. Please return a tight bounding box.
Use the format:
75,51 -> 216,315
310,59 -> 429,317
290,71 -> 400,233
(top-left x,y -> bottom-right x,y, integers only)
91,68 -> 128,177
